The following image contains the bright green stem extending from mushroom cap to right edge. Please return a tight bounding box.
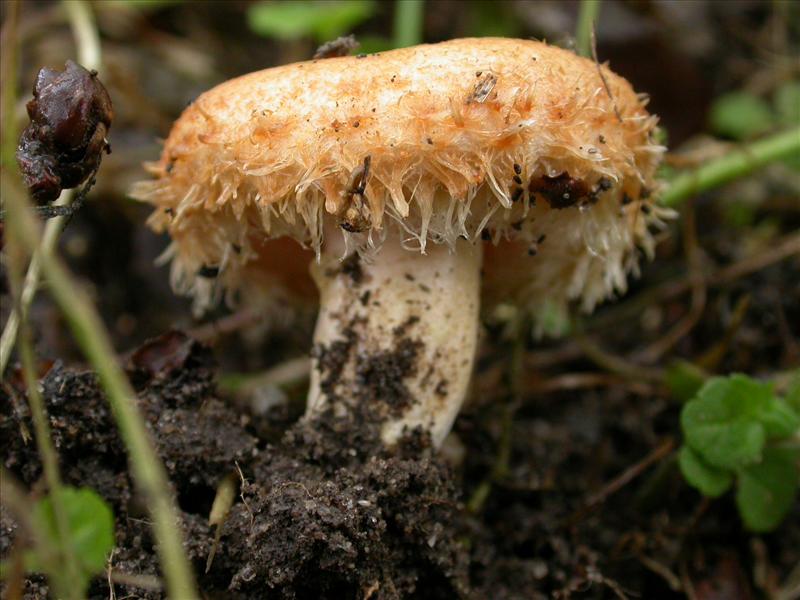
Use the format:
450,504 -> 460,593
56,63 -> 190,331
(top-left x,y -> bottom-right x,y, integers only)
661,127 -> 800,206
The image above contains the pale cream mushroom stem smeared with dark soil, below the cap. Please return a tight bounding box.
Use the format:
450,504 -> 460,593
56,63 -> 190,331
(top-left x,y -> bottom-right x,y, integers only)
306,227 -> 481,447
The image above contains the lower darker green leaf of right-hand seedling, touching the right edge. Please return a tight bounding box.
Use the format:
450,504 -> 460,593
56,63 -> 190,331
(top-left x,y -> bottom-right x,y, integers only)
736,448 -> 800,532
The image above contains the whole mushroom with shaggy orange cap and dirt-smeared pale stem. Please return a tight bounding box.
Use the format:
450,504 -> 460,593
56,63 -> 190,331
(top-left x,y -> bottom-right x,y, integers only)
134,38 -> 663,445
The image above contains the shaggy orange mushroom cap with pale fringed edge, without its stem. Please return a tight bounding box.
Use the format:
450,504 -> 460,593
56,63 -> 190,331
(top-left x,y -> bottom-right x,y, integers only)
134,38 -> 663,318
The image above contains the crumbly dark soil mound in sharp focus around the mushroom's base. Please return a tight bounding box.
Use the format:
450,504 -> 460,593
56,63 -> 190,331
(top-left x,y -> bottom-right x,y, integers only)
0,333 -> 469,599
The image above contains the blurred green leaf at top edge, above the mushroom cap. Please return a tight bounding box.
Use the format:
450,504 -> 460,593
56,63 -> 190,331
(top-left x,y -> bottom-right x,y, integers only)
247,0 -> 375,43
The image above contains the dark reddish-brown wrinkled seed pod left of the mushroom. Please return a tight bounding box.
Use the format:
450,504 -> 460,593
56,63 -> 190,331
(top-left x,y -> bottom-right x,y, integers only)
17,61 -> 113,202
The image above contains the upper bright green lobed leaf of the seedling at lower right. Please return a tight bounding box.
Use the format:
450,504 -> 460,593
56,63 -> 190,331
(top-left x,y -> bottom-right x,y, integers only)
681,375 -> 773,469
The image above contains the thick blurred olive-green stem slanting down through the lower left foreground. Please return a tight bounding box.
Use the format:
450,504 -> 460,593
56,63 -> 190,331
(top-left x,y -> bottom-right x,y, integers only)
2,171 -> 199,600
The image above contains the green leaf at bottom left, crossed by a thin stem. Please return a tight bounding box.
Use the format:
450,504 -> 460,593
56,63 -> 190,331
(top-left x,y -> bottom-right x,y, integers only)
28,487 -> 114,583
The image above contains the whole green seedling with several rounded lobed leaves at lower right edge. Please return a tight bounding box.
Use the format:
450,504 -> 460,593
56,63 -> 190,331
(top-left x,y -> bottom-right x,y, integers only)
678,374 -> 800,532
